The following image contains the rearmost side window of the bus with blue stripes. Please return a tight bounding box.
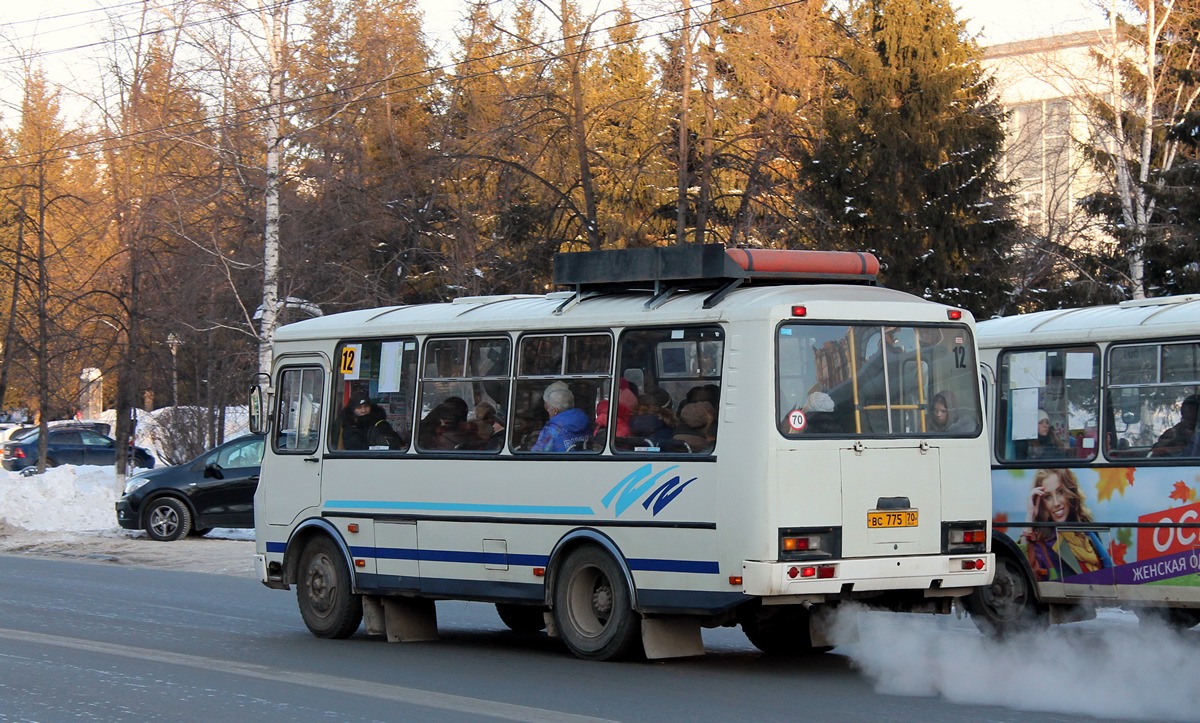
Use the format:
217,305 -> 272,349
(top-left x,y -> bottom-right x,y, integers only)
613,327 -> 725,454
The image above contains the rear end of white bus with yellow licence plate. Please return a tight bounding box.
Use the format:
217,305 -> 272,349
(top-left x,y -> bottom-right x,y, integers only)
740,287 -> 994,650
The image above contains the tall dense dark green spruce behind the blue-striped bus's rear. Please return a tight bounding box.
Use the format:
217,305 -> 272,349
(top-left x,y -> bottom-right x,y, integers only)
804,0 -> 1012,315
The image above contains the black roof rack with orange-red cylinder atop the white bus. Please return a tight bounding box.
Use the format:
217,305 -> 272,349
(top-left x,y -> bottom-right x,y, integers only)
554,244 -> 880,309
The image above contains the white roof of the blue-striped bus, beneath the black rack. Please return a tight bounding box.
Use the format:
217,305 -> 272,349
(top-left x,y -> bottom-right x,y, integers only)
275,283 -> 971,341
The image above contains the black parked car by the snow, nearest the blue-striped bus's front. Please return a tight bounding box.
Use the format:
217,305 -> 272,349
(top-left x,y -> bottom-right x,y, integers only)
116,435 -> 264,542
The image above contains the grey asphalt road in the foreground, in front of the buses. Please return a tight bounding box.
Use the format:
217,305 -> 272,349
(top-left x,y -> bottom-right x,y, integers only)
0,540 -> 1123,722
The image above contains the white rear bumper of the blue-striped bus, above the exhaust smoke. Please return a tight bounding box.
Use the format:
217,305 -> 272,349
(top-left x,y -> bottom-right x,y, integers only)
742,552 -> 996,595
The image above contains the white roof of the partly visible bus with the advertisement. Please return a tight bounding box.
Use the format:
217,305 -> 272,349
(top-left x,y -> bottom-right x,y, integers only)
977,294 -> 1200,347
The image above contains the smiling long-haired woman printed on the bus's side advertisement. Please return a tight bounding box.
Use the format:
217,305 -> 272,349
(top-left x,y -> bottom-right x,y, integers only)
1021,470 -> 1112,581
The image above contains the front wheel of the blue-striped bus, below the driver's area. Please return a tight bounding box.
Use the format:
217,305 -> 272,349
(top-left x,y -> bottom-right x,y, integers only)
296,537 -> 362,638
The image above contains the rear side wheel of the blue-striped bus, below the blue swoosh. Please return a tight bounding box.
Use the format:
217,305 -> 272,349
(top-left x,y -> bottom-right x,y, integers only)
554,546 -> 642,661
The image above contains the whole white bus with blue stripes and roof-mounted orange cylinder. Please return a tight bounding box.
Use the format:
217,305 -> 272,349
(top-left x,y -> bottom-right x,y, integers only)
251,245 -> 994,659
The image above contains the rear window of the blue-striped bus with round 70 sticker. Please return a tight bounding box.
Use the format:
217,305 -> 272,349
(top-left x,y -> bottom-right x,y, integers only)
776,322 -> 982,437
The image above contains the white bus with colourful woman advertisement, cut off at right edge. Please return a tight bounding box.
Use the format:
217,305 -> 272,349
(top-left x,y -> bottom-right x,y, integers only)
966,295 -> 1200,633
